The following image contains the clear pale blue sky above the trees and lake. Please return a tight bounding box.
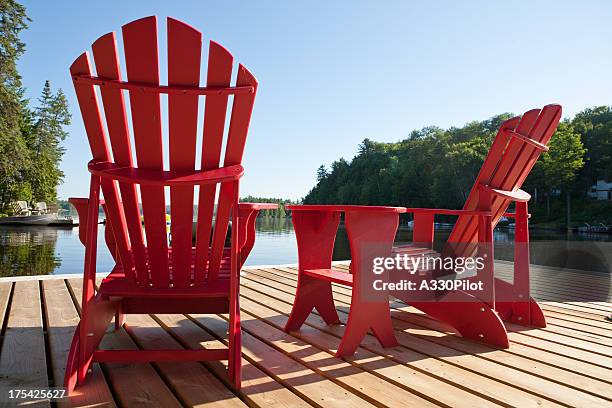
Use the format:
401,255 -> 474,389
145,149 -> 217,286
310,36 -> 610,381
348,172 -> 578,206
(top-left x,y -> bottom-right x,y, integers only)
19,0 -> 612,198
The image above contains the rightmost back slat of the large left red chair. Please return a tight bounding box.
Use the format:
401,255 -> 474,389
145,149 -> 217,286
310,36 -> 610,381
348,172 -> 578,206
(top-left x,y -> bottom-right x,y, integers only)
208,65 -> 257,281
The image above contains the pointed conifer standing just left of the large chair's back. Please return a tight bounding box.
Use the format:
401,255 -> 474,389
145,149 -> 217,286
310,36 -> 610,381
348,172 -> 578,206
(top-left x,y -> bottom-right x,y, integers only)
28,81 -> 70,202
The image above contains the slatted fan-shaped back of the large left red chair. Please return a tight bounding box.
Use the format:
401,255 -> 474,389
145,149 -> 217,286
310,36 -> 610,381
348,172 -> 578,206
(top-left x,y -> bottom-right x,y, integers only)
70,17 -> 257,288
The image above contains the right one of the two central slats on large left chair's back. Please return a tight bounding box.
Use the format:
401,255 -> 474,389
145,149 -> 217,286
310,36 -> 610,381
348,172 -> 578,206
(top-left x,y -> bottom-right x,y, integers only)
168,18 -> 202,287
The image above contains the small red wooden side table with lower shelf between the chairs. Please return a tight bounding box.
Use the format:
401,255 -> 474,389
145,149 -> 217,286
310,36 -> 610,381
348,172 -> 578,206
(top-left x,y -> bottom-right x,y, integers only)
285,205 -> 406,357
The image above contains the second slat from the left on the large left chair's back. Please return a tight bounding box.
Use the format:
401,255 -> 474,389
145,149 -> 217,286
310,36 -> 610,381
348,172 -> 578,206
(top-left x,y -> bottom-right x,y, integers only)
92,33 -> 149,282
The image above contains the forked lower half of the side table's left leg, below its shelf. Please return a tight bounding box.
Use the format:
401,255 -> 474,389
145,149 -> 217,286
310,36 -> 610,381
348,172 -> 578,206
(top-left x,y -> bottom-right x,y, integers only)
285,274 -> 340,332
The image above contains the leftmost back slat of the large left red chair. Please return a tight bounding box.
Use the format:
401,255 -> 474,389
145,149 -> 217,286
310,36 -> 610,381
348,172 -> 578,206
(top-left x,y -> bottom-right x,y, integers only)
70,52 -> 134,277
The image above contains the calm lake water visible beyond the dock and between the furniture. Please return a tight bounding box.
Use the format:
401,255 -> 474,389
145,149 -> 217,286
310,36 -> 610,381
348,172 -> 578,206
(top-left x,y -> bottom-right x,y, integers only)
0,219 -> 612,276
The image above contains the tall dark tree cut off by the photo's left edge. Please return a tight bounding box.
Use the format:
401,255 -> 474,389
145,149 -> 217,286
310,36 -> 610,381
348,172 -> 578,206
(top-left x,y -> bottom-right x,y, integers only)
0,0 -> 29,212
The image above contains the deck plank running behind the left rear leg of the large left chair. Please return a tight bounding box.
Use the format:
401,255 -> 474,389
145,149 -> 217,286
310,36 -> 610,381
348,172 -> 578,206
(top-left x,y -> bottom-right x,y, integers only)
41,279 -> 115,407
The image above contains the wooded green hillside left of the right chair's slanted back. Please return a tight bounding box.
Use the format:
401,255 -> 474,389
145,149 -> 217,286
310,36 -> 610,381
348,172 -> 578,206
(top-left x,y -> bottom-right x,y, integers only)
304,114 -> 511,208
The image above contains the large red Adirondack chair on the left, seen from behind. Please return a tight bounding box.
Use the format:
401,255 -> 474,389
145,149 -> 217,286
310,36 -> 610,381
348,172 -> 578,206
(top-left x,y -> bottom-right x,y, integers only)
65,17 -> 276,390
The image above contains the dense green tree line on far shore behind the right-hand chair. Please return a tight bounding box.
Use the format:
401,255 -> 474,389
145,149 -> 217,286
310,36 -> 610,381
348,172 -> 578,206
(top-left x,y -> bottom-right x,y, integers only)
303,106 -> 612,223
